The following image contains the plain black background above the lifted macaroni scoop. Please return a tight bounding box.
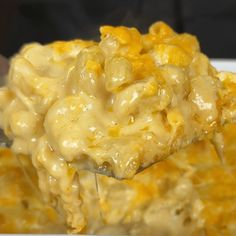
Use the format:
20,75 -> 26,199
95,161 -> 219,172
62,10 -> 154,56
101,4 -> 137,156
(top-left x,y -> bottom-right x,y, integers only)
0,0 -> 236,58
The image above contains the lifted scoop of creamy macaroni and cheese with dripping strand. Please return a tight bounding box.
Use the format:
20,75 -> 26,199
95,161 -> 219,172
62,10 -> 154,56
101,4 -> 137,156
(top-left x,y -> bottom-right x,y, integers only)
0,22 -> 236,232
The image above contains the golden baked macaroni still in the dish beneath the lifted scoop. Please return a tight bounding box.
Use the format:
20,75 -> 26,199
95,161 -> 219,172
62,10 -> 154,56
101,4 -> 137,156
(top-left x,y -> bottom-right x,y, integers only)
0,125 -> 236,236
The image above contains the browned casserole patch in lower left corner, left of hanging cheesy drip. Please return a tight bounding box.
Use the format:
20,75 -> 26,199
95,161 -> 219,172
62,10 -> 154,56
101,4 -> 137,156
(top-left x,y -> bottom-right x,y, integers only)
0,148 -> 66,234
